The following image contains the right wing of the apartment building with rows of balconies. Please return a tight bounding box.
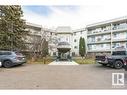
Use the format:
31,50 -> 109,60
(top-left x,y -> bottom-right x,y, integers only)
86,17 -> 127,53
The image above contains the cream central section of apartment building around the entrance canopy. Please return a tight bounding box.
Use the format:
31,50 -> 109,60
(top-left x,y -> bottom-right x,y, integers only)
49,26 -> 86,56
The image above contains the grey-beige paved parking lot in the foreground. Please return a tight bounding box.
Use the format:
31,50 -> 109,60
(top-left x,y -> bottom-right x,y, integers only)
0,64 -> 127,89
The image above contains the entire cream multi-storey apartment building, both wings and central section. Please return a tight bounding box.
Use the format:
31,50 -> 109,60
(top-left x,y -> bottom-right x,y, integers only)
27,17 -> 127,56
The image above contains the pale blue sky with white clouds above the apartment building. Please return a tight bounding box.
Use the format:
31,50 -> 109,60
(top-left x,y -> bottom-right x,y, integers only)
22,0 -> 127,29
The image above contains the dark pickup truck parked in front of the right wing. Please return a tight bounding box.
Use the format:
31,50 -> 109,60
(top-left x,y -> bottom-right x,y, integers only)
95,50 -> 127,69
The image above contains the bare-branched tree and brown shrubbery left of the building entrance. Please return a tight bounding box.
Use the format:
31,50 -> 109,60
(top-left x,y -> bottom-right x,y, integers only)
28,28 -> 57,61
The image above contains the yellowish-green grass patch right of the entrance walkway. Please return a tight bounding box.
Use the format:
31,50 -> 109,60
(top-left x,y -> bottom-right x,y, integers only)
73,58 -> 95,64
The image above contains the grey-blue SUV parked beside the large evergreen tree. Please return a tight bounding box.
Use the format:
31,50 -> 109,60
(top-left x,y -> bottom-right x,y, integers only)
0,51 -> 26,68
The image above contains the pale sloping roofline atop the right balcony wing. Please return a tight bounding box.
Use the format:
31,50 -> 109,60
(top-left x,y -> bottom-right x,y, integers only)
86,16 -> 127,28
